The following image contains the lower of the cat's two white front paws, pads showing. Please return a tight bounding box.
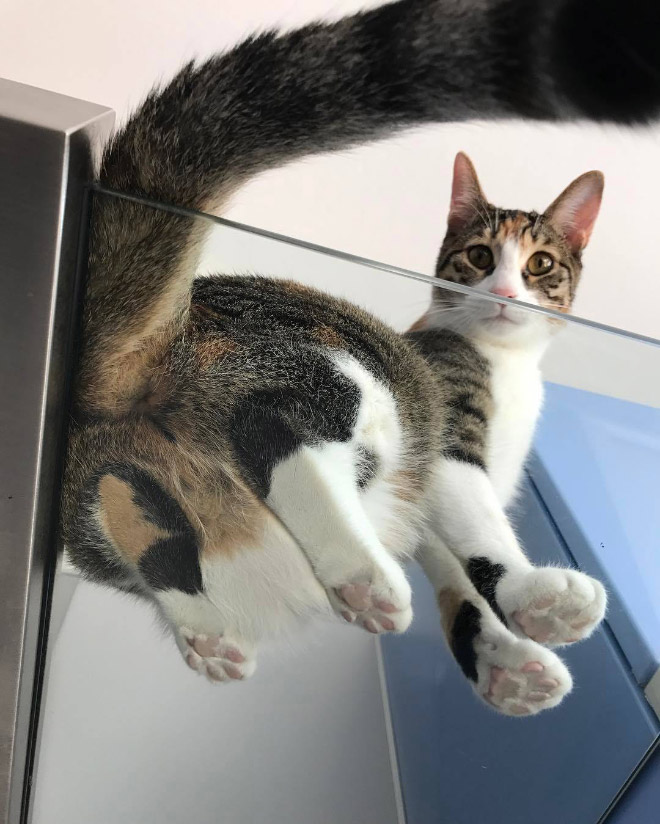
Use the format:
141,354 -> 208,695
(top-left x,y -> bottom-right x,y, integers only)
474,633 -> 573,716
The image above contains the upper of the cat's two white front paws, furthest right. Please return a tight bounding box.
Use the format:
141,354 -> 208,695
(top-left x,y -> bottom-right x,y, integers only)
497,567 -> 607,646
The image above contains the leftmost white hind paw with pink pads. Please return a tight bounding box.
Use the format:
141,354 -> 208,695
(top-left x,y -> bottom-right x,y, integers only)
179,627 -> 256,683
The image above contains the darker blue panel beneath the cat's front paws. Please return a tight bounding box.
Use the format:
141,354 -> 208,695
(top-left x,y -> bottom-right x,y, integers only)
381,484 -> 658,824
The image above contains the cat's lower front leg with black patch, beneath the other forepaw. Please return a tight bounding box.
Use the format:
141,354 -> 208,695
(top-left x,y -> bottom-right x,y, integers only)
418,534 -> 572,716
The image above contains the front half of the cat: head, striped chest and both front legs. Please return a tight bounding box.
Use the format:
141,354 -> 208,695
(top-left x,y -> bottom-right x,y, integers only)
406,153 -> 607,715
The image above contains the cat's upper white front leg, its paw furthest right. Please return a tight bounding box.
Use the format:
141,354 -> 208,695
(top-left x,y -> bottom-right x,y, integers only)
429,458 -> 607,646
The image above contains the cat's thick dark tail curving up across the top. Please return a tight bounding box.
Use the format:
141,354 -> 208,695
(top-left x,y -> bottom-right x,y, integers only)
78,0 -> 660,413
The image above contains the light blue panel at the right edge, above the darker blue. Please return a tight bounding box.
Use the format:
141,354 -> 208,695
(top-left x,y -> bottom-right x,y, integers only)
529,384 -> 660,686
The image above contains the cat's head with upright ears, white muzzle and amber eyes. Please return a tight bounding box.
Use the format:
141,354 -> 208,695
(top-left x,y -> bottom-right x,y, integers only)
428,152 -> 604,345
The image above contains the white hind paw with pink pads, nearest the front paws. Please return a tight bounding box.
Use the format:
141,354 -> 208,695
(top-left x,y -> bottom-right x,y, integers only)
330,568 -> 412,634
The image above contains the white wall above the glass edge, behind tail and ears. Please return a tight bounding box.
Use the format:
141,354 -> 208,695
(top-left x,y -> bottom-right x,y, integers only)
0,0 -> 660,337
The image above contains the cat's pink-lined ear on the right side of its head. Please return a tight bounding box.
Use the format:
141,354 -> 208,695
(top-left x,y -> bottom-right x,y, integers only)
545,172 -> 605,254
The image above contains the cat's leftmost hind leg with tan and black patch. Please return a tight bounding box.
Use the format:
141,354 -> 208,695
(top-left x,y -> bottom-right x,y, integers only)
86,463 -> 260,681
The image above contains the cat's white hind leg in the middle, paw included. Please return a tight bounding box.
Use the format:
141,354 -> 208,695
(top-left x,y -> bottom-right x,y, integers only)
266,442 -> 412,633
